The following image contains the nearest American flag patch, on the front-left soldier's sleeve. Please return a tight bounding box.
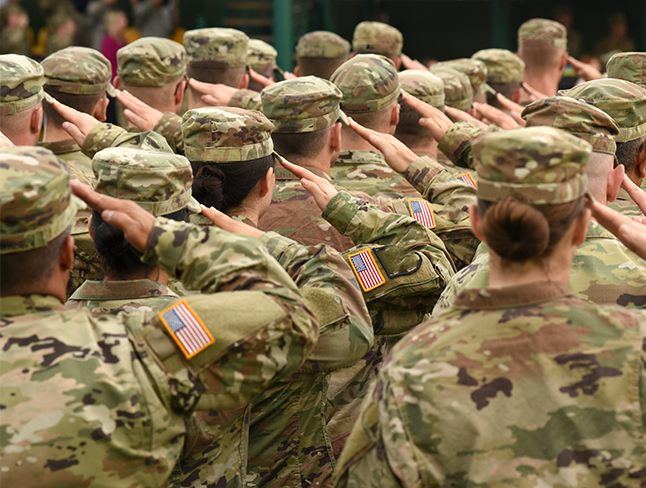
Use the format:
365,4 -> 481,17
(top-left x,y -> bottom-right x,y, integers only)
159,300 -> 215,359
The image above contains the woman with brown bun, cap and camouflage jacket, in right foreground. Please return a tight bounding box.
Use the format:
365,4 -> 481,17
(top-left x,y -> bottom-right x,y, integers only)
336,127 -> 646,488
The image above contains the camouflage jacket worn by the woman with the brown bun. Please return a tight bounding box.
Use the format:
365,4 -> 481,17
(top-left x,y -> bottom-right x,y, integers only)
335,282 -> 646,488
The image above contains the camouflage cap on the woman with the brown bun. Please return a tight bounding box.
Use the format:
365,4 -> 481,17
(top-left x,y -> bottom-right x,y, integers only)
473,127 -> 592,205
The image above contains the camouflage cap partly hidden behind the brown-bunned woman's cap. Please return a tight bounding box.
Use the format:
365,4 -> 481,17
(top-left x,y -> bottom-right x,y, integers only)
521,97 -> 619,156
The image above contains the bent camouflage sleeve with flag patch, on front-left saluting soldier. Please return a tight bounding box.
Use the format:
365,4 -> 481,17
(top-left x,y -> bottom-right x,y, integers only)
133,218 -> 318,412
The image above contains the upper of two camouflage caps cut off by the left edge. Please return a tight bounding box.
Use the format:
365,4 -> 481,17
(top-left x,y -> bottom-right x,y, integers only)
0,54 -> 51,116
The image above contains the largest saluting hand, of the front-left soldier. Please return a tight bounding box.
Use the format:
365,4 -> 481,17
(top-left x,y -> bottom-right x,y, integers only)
70,180 -> 155,252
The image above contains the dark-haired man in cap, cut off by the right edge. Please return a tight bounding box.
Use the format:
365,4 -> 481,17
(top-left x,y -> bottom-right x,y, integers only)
562,78 -> 646,216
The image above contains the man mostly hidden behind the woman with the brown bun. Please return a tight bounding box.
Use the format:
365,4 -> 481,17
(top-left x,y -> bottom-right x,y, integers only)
433,97 -> 646,315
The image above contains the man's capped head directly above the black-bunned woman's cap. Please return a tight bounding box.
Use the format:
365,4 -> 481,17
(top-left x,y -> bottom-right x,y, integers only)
184,27 -> 249,108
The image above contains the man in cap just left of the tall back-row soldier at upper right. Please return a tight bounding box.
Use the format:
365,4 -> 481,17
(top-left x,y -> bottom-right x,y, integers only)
471,49 -> 525,111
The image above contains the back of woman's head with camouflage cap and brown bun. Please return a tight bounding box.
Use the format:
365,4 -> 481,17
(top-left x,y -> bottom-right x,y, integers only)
473,127 -> 592,263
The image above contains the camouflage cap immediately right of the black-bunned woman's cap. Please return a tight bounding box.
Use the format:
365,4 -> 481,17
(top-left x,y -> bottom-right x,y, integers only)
260,76 -> 349,134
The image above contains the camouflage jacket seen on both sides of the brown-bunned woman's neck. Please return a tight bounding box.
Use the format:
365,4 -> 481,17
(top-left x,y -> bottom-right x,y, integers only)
433,222 -> 646,316
